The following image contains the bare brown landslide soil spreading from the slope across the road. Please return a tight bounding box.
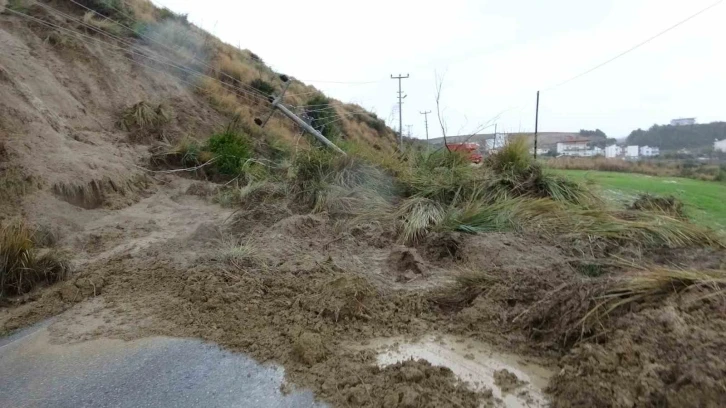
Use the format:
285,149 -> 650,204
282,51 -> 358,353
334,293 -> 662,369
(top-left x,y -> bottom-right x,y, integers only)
0,8 -> 726,407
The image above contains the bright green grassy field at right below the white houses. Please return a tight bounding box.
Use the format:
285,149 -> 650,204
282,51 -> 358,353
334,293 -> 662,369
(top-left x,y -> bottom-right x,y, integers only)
552,170 -> 726,229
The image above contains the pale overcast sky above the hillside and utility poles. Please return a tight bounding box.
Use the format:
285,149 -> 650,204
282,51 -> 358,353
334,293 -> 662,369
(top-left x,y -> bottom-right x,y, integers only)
154,0 -> 726,138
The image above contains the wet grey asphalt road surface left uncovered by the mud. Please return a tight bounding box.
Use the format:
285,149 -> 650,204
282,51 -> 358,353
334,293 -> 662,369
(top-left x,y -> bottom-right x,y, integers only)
0,323 -> 323,408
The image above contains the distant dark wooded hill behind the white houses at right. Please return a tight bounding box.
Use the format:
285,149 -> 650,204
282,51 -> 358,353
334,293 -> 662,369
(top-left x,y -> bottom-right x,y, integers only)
626,122 -> 726,151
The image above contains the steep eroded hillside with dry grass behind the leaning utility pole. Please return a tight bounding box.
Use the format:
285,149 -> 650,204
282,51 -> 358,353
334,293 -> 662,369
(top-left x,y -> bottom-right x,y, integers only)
0,0 -> 394,214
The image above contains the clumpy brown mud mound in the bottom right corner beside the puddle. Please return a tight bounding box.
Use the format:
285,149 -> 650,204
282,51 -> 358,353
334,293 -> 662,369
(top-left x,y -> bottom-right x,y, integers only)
549,298 -> 726,407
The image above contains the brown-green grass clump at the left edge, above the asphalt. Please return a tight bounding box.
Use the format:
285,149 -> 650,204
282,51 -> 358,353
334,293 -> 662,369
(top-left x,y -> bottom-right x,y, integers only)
0,222 -> 70,297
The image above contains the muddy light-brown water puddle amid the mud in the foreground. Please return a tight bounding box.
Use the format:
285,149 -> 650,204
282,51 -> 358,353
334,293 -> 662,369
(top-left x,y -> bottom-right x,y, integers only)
353,335 -> 552,408
